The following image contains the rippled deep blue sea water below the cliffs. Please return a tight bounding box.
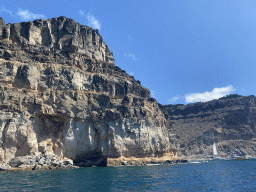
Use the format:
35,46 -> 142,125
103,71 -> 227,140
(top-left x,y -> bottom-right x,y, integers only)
0,160 -> 256,192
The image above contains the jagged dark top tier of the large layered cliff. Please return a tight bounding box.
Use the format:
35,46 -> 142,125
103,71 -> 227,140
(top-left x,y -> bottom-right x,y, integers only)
0,16 -> 114,63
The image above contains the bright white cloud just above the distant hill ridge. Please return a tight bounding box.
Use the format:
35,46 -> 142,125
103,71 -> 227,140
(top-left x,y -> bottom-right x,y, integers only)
185,85 -> 235,103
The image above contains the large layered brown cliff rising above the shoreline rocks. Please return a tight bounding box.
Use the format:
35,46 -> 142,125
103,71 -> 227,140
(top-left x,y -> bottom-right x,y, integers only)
0,17 -> 175,164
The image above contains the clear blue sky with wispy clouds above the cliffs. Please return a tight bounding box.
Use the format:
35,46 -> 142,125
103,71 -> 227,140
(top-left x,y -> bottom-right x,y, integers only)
0,0 -> 256,104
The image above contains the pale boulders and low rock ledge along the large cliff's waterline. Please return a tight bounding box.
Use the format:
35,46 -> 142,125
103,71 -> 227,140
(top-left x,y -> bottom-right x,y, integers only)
0,152 -> 187,171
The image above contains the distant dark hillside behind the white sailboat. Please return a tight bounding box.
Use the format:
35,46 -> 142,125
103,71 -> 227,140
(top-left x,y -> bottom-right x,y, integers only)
164,95 -> 256,158
